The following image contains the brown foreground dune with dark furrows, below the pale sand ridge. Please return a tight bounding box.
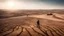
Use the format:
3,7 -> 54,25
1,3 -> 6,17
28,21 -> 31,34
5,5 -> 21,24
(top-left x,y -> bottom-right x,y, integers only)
0,17 -> 64,36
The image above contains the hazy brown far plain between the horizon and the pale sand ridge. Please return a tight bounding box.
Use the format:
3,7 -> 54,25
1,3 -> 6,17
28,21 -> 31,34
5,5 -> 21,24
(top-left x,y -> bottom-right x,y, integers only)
0,9 -> 64,18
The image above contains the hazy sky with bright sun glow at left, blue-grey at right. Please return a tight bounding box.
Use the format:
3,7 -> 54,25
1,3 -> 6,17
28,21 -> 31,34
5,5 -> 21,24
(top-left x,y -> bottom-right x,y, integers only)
0,0 -> 64,9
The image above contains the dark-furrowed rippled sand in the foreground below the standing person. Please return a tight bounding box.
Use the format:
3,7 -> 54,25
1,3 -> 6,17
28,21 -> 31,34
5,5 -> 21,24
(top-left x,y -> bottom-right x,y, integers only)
2,25 -> 64,36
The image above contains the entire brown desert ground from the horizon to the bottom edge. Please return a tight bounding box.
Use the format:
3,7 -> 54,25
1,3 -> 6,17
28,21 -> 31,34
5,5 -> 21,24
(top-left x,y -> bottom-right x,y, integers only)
0,10 -> 64,36
